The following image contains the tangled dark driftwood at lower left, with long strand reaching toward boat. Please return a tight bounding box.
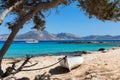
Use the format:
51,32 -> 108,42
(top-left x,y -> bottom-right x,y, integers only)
0,57 -> 64,80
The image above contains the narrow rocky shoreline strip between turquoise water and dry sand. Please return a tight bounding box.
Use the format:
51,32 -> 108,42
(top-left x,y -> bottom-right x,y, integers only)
4,43 -> 120,59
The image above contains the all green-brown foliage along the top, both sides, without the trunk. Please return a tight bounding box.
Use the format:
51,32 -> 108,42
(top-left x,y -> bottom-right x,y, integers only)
0,0 -> 120,29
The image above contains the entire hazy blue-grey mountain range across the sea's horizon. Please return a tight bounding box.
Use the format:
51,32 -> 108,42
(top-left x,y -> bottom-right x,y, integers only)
0,30 -> 120,41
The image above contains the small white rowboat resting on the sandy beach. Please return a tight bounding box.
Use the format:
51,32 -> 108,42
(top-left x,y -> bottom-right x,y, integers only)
59,56 -> 83,71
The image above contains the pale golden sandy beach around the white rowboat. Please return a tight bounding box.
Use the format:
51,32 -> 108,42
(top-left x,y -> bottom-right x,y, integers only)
2,47 -> 120,80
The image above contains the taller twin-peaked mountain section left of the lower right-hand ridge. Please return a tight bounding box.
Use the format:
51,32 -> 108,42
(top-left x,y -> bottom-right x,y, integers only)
15,30 -> 80,40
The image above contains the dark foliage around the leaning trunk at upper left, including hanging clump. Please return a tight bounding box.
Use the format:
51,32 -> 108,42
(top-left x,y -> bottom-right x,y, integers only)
0,0 -> 74,30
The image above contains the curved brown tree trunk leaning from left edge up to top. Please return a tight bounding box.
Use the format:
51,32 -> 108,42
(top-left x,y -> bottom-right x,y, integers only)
0,0 -> 63,75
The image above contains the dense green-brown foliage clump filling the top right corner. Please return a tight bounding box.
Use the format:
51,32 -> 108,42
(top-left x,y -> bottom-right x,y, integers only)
79,0 -> 120,21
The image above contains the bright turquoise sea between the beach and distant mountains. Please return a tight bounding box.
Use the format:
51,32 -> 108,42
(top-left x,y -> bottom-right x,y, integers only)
0,41 -> 120,57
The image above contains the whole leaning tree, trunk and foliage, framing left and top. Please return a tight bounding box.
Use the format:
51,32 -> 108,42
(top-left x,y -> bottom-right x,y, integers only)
0,0 -> 120,75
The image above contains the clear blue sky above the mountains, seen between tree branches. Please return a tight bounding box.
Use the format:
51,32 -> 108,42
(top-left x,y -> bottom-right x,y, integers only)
0,4 -> 120,36
